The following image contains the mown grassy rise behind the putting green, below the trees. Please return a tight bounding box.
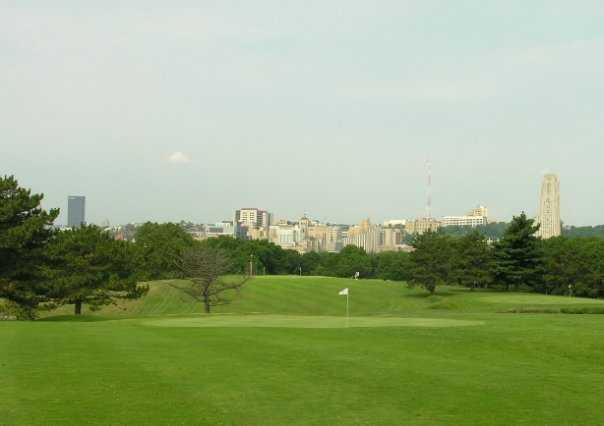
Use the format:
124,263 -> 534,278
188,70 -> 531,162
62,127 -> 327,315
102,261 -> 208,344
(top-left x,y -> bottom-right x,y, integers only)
46,276 -> 604,317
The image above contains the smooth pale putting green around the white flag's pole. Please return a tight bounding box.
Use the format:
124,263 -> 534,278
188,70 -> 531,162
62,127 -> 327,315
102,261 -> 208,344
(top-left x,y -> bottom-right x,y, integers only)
143,315 -> 484,328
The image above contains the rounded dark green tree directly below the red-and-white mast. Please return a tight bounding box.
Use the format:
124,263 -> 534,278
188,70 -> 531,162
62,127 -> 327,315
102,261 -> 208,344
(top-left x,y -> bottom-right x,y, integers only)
411,231 -> 452,294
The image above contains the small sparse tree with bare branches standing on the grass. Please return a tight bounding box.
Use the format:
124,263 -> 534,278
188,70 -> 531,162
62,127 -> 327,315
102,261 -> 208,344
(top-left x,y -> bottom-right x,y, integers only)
177,247 -> 248,314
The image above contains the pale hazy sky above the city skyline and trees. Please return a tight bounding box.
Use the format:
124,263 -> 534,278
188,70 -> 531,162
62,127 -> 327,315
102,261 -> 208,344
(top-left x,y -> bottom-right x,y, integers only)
0,0 -> 604,225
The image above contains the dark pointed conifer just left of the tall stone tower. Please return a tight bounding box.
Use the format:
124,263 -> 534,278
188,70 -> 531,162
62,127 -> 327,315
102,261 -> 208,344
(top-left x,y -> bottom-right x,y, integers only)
493,212 -> 544,290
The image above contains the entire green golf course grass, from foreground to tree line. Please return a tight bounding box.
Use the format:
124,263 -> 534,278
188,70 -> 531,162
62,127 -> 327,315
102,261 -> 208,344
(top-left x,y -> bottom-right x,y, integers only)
0,277 -> 604,426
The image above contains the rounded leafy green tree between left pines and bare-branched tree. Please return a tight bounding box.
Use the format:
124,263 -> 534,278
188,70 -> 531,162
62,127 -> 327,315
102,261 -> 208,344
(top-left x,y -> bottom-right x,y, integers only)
135,222 -> 194,279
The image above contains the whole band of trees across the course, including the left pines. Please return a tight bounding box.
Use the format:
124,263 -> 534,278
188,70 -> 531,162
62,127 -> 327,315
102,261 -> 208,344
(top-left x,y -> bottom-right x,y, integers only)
0,177 -> 604,318
